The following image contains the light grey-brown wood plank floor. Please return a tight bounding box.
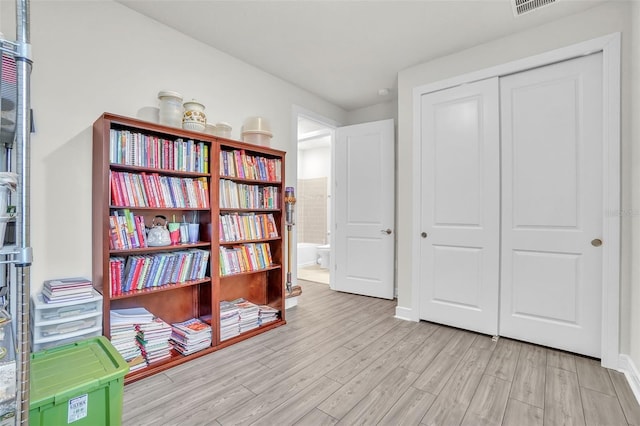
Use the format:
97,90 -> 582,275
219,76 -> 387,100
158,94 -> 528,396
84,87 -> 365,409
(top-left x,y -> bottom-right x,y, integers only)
123,281 -> 640,426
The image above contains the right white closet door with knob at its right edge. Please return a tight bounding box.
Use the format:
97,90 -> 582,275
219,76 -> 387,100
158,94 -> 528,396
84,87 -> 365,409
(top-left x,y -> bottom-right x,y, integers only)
500,54 -> 607,357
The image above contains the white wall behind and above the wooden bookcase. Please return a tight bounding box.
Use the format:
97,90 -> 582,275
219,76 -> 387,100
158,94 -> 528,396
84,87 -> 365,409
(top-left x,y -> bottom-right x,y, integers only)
0,0 -> 345,292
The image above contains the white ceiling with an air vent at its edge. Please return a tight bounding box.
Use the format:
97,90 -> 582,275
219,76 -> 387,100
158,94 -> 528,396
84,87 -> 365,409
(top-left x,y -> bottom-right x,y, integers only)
116,0 -> 604,111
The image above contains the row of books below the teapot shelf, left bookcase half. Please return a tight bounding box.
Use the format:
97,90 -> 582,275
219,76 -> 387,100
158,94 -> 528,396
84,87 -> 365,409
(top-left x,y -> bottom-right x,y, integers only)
109,249 -> 209,296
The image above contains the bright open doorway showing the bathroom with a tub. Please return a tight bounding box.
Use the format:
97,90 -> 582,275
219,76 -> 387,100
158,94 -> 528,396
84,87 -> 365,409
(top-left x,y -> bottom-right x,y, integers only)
296,113 -> 335,285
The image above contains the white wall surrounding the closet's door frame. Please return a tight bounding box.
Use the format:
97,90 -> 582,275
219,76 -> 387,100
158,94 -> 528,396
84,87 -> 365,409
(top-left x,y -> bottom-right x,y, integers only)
396,2 -> 640,356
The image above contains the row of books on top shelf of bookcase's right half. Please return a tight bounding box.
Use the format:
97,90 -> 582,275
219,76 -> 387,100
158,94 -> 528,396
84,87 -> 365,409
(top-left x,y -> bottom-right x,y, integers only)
220,149 -> 282,182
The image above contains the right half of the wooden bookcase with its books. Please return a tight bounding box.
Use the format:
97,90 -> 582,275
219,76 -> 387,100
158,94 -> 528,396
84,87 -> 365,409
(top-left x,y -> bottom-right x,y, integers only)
216,141 -> 285,346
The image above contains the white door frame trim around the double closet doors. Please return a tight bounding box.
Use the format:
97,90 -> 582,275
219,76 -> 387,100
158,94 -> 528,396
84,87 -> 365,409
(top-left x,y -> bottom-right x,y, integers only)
410,33 -> 621,369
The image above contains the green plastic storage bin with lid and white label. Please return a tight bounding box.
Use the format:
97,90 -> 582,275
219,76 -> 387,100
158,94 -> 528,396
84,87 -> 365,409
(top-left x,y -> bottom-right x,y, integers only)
29,336 -> 129,426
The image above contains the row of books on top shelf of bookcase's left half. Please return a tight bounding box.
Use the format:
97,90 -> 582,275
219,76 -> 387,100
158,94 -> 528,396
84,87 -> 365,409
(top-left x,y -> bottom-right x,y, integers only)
109,129 -> 209,173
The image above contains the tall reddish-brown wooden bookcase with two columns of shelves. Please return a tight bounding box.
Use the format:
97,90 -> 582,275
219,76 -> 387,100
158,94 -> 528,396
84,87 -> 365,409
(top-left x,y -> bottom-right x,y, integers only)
92,113 -> 285,383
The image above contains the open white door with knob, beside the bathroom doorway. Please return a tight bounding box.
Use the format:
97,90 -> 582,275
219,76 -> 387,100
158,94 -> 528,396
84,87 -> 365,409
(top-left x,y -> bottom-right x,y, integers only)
331,120 -> 395,299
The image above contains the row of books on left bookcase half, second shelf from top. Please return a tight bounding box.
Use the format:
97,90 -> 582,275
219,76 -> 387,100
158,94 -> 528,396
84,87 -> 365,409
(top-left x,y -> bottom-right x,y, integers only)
109,170 -> 209,209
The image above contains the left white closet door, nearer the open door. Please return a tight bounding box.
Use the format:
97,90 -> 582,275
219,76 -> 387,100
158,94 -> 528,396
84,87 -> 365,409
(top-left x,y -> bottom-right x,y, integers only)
419,78 -> 500,335
